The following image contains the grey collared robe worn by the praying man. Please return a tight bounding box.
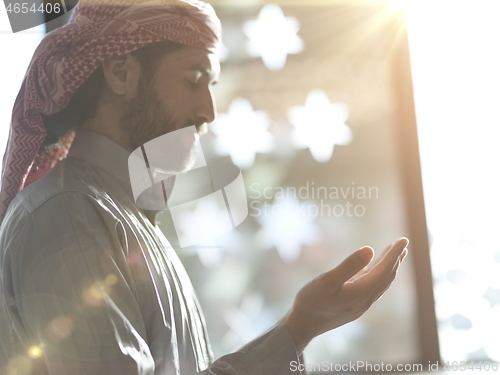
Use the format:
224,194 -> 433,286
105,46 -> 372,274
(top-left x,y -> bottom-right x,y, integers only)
0,129 -> 299,375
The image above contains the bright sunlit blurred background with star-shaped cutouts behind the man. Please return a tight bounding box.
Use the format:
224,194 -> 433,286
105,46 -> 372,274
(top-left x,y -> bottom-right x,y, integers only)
0,0 -> 500,372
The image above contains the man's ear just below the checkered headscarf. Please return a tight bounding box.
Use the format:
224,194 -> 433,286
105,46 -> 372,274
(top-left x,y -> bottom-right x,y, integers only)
102,53 -> 141,99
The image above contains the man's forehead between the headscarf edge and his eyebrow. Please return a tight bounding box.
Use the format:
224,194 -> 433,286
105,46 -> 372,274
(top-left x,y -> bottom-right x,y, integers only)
156,46 -> 220,80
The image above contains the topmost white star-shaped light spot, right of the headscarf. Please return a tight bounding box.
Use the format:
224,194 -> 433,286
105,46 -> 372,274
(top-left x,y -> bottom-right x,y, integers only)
243,4 -> 304,70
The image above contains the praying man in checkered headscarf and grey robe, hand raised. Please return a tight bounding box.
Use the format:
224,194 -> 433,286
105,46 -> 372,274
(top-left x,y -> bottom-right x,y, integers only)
0,0 -> 408,375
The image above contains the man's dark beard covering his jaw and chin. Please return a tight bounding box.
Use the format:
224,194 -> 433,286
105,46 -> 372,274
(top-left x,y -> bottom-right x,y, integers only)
120,72 -> 199,174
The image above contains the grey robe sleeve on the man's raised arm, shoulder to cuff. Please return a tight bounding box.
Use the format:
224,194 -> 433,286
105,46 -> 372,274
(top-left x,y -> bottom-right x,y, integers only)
0,192 -> 300,375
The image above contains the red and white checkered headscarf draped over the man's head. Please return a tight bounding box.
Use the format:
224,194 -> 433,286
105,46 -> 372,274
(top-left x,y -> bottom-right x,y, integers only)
0,0 -> 221,223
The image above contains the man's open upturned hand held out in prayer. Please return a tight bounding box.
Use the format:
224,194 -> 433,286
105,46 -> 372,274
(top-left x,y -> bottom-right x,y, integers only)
278,237 -> 409,352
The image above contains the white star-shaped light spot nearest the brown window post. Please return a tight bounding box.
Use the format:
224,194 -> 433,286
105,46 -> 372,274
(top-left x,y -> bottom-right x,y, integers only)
288,90 -> 352,163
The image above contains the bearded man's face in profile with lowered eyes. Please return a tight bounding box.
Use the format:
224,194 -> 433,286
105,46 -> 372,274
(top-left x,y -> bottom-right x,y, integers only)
120,46 -> 220,171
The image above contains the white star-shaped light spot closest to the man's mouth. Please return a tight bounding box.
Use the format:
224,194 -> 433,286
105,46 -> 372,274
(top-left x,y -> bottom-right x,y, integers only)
210,98 -> 275,169
